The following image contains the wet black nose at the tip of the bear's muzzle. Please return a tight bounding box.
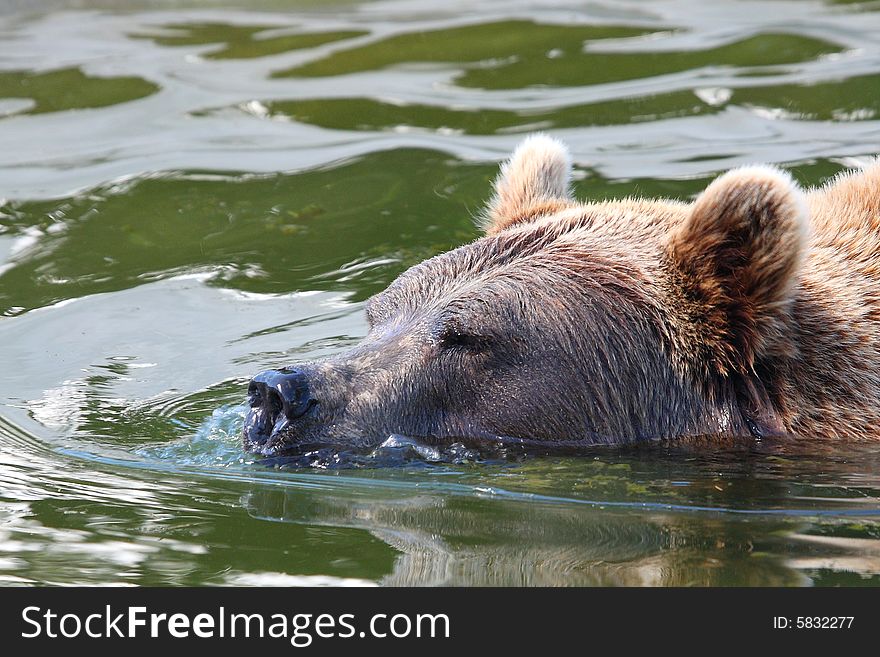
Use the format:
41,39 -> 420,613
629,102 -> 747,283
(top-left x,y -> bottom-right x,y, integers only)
244,368 -> 318,453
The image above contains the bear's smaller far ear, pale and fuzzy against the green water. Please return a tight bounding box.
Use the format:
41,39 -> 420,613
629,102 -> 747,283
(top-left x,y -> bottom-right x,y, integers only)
480,134 -> 571,235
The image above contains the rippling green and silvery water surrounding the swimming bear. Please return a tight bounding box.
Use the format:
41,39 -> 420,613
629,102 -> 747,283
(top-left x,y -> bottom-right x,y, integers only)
0,0 -> 880,585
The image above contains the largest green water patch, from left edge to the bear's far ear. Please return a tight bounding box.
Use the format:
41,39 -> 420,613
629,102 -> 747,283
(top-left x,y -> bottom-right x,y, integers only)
0,150 -> 494,312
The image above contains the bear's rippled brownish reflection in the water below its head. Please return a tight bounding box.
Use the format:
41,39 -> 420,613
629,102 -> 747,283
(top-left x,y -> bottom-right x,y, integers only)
244,482 -> 820,586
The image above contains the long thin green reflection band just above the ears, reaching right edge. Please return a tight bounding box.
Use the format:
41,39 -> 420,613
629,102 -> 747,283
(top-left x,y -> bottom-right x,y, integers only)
211,75 -> 880,135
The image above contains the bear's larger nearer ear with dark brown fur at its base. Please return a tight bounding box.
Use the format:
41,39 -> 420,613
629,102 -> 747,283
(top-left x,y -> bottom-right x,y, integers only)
666,166 -> 809,375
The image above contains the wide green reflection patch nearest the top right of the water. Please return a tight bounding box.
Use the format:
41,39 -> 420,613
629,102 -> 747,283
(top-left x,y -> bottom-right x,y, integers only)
274,21 -> 843,89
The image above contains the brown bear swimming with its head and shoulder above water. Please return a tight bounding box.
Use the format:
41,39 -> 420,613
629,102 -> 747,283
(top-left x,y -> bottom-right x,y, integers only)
244,135 -> 880,454
